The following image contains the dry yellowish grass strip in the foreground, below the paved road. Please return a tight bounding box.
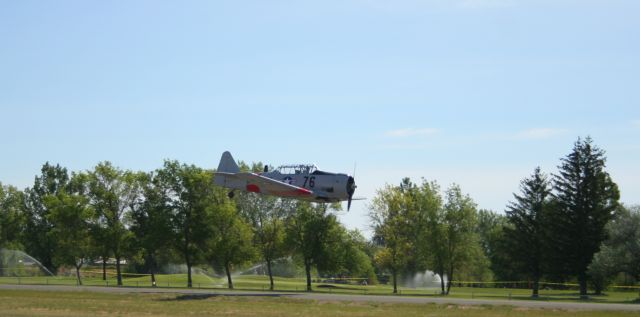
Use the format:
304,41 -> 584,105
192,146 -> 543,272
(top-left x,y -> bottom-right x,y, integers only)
0,290 -> 637,317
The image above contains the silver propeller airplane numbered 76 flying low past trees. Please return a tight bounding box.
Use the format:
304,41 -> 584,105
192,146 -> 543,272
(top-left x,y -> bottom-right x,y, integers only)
215,151 -> 357,210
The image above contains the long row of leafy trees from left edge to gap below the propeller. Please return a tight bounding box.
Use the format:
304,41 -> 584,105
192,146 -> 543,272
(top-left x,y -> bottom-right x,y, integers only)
0,160 -> 375,290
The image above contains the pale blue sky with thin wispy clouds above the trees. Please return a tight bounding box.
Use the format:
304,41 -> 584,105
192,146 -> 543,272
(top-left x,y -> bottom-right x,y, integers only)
0,0 -> 640,236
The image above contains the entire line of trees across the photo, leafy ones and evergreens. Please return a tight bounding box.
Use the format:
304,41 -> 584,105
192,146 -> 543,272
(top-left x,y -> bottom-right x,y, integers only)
0,138 -> 640,296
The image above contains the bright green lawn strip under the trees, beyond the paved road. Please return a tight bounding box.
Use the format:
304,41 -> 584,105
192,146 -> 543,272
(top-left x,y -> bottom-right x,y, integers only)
0,274 -> 639,304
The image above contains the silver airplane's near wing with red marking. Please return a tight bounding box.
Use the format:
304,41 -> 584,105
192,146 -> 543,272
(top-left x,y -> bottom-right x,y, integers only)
216,172 -> 313,197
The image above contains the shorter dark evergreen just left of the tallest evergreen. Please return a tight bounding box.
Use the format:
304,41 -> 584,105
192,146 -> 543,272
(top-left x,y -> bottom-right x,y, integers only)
504,167 -> 551,298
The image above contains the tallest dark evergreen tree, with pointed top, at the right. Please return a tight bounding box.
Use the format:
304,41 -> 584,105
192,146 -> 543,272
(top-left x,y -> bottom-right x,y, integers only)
551,137 -> 620,298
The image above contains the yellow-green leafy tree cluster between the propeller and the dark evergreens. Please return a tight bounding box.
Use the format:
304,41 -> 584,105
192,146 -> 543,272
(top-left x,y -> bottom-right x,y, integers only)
370,178 -> 480,294
